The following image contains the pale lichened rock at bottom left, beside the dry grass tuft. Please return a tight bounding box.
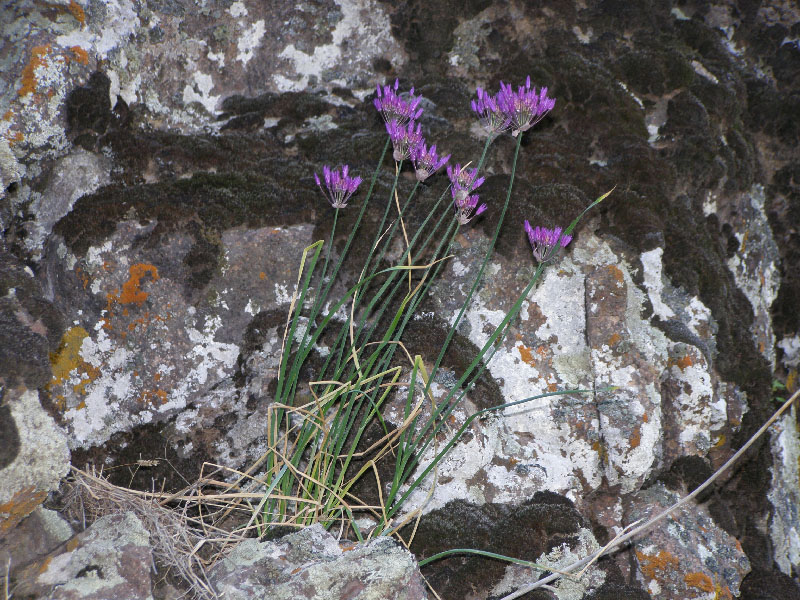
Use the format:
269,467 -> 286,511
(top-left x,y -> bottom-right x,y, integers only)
15,512 -> 153,600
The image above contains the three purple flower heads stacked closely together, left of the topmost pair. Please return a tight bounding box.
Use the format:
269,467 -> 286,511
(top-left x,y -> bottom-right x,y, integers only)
373,80 -> 450,181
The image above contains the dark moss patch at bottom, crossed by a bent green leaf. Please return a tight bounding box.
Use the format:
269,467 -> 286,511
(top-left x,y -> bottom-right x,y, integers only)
410,492 -> 587,600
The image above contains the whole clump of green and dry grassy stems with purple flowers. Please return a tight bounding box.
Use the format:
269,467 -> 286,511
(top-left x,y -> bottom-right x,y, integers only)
217,78 -> 608,540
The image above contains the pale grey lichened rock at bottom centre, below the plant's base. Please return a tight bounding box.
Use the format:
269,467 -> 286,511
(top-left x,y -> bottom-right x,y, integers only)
210,525 -> 427,600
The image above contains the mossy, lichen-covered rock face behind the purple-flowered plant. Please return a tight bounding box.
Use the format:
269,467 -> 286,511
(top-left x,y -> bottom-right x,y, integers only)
0,0 -> 800,600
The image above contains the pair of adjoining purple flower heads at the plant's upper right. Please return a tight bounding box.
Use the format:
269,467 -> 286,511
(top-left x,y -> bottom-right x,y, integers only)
472,76 -> 556,137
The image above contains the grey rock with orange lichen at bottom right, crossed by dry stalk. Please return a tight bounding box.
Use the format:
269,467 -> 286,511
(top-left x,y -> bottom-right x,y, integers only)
625,483 -> 750,600
